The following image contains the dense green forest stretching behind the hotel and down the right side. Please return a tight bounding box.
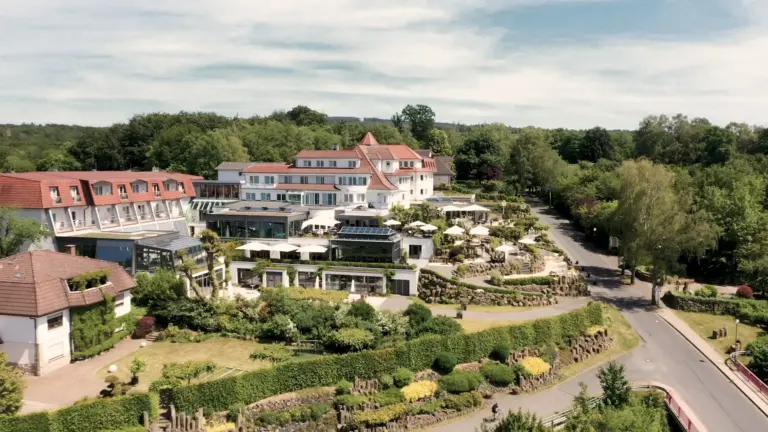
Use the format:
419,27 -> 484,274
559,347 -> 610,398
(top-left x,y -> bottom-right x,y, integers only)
0,105 -> 768,292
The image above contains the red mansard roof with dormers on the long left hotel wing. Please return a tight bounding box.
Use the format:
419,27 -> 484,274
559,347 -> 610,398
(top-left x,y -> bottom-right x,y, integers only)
0,171 -> 202,208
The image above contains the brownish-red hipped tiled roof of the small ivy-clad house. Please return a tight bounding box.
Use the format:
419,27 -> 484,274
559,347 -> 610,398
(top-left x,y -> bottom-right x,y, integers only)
0,251 -> 135,317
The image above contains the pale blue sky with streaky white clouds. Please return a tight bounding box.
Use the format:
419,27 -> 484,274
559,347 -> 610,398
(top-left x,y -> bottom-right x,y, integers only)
0,0 -> 768,129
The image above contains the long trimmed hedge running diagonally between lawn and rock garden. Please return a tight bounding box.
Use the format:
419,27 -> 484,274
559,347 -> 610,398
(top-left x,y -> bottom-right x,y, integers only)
170,302 -> 603,413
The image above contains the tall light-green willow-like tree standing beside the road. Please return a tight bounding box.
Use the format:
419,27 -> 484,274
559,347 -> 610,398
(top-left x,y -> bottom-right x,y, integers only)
615,160 -> 718,304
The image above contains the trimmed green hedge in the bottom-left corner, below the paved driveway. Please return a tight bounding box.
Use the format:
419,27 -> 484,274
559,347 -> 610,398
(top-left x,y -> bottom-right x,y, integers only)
0,393 -> 159,432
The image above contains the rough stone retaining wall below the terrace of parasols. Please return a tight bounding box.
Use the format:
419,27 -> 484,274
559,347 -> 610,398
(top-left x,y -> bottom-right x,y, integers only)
419,270 -> 557,306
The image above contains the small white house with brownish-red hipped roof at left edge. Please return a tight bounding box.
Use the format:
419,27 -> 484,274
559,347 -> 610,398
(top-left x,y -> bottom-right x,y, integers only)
0,251 -> 134,375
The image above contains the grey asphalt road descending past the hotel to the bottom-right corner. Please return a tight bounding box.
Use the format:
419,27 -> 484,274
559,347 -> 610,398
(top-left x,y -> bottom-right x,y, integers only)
530,202 -> 768,432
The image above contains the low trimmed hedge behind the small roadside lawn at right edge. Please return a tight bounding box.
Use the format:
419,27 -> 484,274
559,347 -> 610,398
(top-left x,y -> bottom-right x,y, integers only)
662,291 -> 768,326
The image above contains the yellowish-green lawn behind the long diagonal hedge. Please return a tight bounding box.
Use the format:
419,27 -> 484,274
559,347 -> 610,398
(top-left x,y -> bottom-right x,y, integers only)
98,337 -> 271,390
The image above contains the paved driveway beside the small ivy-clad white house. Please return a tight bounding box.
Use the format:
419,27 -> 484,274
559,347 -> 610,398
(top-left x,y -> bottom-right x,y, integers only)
21,339 -> 151,413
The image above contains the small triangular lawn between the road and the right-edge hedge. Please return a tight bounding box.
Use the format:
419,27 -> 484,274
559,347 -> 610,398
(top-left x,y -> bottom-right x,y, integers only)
674,310 -> 765,361
